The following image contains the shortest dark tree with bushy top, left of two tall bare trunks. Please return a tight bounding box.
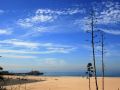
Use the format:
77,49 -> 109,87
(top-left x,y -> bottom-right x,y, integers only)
86,63 -> 94,90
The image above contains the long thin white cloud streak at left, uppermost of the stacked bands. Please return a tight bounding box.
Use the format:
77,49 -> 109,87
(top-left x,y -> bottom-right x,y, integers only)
0,39 -> 75,52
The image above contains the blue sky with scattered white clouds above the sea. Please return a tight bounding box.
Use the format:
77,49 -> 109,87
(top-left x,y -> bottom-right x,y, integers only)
0,0 -> 120,71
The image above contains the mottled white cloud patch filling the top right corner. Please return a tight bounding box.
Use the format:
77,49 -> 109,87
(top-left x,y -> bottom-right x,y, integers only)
97,1 -> 120,24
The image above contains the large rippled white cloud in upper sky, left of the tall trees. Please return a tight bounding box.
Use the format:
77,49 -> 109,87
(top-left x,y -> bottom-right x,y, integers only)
17,8 -> 85,38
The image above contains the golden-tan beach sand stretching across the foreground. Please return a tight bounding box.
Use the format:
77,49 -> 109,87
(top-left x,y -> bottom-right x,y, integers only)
3,76 -> 120,90
